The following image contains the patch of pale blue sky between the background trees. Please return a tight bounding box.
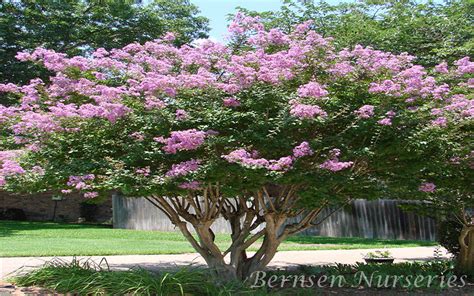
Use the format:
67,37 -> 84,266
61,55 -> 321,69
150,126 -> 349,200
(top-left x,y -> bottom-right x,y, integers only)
190,0 -> 348,41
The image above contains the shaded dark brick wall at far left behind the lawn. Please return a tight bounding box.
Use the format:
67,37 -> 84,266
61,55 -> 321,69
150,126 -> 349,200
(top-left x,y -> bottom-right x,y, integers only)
0,191 -> 112,223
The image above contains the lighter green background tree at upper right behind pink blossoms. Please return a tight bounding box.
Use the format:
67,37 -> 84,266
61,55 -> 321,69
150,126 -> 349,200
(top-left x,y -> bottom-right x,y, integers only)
241,0 -> 474,66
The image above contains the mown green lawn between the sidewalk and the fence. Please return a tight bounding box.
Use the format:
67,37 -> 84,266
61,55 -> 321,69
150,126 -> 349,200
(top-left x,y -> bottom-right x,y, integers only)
0,221 -> 436,257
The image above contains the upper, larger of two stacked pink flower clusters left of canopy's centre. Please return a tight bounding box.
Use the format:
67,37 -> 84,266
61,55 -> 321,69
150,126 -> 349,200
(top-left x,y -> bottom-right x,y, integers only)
154,129 -> 207,154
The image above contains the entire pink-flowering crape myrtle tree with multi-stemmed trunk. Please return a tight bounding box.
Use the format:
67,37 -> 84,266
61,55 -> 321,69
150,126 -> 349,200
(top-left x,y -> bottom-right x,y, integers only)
0,14 -> 473,279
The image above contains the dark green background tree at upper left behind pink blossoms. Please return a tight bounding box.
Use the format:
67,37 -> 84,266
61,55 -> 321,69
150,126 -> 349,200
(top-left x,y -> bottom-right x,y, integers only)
0,0 -> 209,88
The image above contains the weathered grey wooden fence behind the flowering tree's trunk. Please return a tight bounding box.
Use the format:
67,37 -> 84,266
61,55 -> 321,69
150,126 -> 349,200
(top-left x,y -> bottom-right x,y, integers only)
112,196 -> 436,241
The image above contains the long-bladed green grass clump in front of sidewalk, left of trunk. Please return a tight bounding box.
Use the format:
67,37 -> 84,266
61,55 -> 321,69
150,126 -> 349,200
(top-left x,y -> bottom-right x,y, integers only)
12,259 -> 243,295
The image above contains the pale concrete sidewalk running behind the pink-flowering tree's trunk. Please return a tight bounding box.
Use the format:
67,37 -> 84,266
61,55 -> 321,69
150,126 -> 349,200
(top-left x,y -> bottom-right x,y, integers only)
0,247 -> 449,279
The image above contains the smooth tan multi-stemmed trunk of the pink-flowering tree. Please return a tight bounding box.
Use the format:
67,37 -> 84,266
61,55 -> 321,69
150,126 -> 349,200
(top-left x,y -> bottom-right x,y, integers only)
147,184 -> 344,282
